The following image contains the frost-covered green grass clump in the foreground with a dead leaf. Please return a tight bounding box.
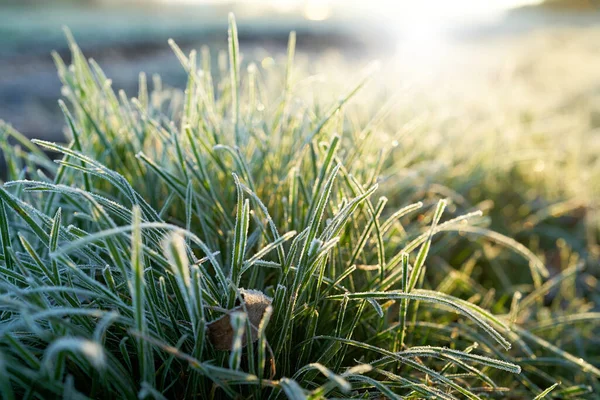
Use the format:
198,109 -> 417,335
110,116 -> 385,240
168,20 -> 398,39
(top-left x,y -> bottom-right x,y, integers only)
0,17 -> 600,399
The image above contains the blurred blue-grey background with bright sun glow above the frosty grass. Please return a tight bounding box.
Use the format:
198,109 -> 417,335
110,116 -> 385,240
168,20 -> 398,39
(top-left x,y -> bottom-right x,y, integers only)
0,0 -> 600,140
